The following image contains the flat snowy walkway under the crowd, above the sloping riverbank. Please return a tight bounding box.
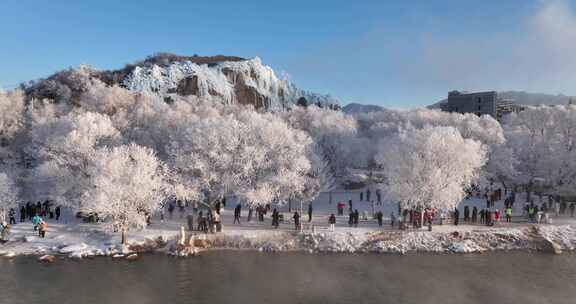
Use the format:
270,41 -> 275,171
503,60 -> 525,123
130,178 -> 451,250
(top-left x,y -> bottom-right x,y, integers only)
0,192 -> 576,255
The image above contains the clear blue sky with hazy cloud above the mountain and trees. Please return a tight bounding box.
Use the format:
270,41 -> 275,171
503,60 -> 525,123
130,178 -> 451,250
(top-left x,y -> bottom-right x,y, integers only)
0,0 -> 576,107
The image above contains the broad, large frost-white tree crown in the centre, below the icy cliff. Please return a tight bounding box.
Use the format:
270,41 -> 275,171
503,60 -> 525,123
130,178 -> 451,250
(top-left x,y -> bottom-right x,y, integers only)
169,103 -> 311,208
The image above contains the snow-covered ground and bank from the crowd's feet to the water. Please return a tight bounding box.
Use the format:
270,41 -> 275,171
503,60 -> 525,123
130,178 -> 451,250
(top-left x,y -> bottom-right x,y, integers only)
0,192 -> 576,257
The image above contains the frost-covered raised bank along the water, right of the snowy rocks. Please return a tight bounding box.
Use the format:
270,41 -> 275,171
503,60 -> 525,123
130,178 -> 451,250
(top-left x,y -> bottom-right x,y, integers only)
159,226 -> 576,254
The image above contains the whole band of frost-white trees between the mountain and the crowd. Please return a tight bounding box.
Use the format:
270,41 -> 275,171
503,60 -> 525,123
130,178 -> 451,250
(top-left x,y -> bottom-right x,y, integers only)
0,71 -> 576,240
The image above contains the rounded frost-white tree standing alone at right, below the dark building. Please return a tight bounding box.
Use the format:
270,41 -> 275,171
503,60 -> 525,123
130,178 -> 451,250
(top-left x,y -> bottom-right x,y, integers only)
376,127 -> 486,210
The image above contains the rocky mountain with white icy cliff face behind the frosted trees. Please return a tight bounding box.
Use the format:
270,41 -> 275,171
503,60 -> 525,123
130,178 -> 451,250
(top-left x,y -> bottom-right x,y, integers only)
23,53 -> 339,110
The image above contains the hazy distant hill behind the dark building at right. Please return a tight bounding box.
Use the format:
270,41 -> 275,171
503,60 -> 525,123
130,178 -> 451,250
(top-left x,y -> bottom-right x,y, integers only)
428,91 -> 576,109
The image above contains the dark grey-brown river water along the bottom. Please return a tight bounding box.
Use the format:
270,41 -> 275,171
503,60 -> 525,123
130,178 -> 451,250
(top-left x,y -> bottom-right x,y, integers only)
0,252 -> 576,304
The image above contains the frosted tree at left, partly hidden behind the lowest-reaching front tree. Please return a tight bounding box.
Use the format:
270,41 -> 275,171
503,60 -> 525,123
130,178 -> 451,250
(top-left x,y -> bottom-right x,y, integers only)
28,112 -> 120,207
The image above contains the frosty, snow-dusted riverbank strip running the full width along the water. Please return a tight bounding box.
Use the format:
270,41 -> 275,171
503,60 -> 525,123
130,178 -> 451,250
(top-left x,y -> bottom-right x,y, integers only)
0,220 -> 576,258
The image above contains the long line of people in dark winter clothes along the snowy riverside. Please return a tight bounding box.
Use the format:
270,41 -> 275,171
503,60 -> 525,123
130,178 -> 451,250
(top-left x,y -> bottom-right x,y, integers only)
0,189 -> 576,242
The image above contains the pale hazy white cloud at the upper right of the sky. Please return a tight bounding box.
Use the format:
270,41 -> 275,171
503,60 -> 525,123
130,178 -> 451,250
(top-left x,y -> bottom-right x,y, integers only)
397,1 -> 576,94
